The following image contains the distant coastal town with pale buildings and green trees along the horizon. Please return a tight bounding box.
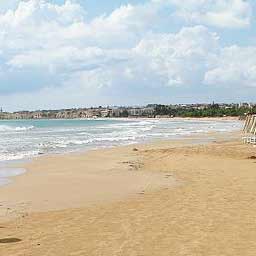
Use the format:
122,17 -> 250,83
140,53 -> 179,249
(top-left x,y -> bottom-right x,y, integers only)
0,102 -> 256,120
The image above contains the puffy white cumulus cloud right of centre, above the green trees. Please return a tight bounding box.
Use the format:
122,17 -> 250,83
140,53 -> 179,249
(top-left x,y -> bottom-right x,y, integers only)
131,26 -> 219,86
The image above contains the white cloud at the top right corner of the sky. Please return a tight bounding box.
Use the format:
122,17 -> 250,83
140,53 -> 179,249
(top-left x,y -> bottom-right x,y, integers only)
153,0 -> 252,28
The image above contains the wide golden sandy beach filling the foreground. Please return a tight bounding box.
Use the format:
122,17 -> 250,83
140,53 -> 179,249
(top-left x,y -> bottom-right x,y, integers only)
0,133 -> 256,256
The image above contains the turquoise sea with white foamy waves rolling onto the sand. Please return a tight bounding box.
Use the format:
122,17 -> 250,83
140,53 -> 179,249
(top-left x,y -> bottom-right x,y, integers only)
0,119 -> 242,185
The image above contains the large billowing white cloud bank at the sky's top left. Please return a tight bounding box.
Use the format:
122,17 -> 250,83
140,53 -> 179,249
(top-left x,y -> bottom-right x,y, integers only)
0,0 -> 157,50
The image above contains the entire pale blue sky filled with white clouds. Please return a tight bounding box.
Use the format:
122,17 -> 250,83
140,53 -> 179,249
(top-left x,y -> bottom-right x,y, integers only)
0,0 -> 256,111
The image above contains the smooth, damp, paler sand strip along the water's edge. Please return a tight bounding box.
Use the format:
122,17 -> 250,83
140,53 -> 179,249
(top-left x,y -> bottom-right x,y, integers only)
0,131 -> 239,222
